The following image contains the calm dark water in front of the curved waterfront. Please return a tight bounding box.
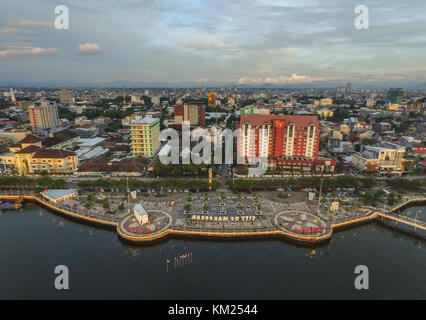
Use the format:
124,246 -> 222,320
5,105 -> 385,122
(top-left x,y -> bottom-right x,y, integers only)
0,205 -> 426,299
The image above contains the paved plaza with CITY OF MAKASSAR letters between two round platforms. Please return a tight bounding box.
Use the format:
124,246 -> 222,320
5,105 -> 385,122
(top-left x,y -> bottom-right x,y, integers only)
23,190 -> 378,237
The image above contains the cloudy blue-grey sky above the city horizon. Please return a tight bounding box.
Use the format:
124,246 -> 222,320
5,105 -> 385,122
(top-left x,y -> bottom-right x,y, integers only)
0,0 -> 426,87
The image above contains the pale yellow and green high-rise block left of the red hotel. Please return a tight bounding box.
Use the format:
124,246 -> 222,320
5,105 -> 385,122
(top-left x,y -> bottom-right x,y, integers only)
131,117 -> 160,158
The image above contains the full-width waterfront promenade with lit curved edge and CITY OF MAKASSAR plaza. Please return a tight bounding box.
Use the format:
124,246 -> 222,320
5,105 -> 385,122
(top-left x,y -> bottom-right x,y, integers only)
0,189 -> 426,244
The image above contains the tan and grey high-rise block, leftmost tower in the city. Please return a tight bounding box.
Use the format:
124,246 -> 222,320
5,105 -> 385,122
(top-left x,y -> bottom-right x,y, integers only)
28,102 -> 62,135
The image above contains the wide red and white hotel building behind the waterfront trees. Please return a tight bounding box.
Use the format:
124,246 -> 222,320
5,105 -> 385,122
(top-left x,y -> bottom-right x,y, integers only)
237,115 -> 336,171
